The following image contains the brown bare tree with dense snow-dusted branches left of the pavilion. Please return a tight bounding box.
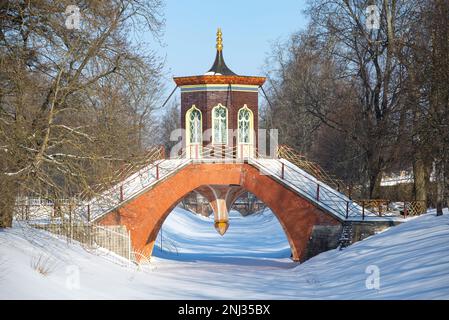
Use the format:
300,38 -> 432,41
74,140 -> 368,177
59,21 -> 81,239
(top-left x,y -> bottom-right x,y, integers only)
0,0 -> 163,227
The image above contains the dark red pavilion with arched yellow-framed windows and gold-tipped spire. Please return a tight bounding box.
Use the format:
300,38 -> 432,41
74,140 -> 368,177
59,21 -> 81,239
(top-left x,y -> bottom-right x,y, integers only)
174,29 -> 265,158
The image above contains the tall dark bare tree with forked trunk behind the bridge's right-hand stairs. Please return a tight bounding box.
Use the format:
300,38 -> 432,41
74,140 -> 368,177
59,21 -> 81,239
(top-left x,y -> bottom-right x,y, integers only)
309,0 -> 415,197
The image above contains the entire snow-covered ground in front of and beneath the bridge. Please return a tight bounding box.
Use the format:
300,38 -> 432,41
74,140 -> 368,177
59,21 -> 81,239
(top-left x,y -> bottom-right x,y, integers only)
0,209 -> 449,299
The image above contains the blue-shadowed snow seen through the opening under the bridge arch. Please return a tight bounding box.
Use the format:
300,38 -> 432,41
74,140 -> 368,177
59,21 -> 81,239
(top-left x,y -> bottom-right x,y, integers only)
154,209 -> 290,261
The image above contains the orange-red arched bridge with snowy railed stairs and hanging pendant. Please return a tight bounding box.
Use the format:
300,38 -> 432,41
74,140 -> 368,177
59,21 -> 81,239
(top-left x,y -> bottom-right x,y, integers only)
80,150 -> 396,261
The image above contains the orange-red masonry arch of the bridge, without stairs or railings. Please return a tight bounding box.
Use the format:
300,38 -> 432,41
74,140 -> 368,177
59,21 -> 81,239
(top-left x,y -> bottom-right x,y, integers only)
98,163 -> 340,261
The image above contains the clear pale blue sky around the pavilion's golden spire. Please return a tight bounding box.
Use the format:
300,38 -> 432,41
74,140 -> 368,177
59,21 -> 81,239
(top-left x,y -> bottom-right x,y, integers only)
153,0 -> 307,90
